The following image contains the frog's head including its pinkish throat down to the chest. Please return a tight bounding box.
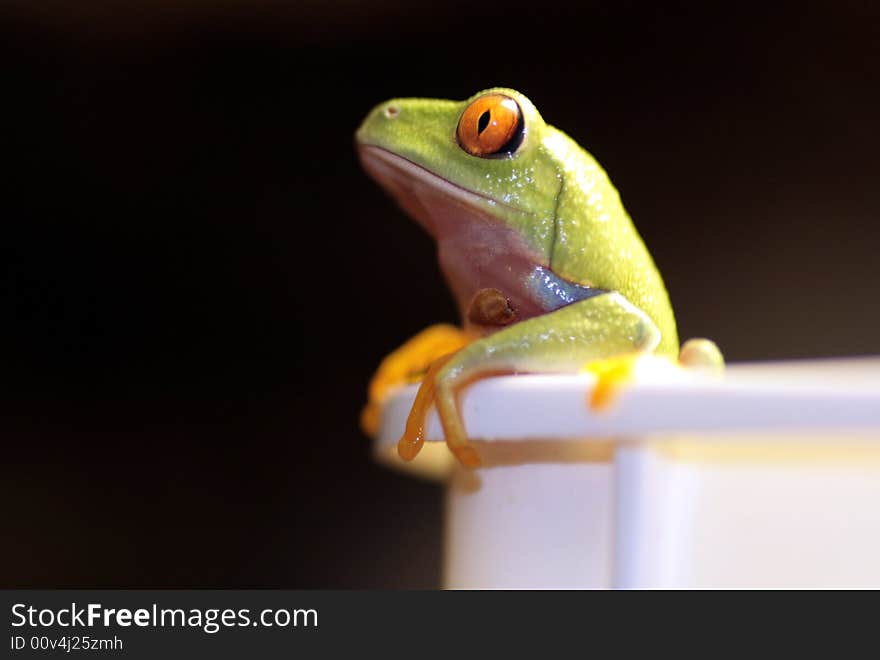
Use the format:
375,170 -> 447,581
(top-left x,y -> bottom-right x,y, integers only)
355,87 -> 562,317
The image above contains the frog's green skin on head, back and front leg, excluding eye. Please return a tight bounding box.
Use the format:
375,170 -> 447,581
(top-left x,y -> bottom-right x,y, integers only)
356,88 -> 720,458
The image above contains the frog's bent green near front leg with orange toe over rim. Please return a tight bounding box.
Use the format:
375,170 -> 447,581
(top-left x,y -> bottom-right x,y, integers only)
401,292 -> 660,467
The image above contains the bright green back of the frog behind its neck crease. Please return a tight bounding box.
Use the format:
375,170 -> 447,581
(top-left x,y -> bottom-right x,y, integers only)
543,126 -> 678,356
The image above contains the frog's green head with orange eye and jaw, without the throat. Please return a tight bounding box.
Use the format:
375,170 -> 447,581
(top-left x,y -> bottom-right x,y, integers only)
356,87 -> 561,261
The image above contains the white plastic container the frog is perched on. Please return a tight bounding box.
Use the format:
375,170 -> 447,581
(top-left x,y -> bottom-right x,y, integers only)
375,358 -> 880,588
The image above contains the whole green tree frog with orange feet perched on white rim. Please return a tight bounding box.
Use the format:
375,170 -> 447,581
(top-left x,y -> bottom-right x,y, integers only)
355,87 -> 724,468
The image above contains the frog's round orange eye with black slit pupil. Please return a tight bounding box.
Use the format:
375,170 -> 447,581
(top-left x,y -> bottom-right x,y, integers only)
457,94 -> 523,158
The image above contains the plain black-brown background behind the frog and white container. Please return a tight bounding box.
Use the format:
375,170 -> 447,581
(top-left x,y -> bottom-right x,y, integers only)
0,0 -> 880,588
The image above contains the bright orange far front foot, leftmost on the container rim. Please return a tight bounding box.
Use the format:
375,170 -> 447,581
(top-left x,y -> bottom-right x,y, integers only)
361,324 -> 472,436
